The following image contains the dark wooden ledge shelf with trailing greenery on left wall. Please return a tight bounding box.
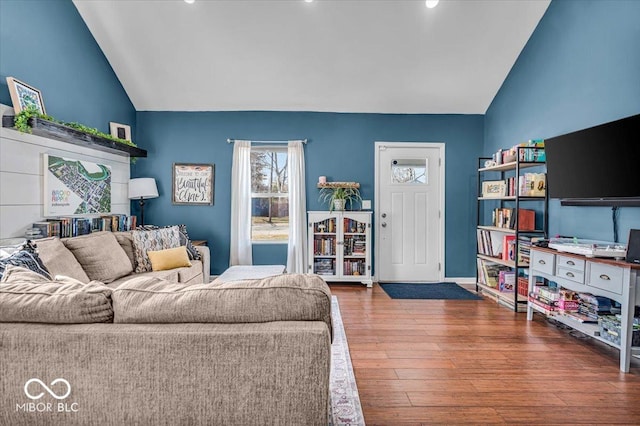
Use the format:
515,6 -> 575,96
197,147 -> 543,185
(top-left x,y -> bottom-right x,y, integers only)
2,115 -> 147,157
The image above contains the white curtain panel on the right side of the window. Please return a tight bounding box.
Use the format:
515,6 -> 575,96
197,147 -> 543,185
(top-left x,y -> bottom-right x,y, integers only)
287,141 -> 307,274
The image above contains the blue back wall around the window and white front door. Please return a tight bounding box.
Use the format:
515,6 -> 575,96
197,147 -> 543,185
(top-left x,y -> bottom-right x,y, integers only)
138,112 -> 483,277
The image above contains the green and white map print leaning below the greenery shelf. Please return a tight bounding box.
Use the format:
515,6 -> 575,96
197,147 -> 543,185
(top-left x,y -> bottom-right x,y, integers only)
43,154 -> 111,216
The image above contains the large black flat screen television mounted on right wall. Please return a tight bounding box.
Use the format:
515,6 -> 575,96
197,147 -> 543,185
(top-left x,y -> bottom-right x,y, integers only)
545,114 -> 640,207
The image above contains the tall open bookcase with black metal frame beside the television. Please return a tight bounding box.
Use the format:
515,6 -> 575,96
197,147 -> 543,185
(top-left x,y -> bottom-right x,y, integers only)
476,140 -> 549,312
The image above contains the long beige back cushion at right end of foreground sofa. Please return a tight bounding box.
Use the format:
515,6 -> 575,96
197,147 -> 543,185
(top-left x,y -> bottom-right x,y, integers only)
112,274 -> 331,330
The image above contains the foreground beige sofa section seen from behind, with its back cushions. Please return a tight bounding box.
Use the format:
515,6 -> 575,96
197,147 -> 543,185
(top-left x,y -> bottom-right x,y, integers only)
0,267 -> 332,426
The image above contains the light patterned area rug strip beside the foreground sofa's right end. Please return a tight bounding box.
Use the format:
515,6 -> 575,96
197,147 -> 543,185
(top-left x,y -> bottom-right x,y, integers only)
329,296 -> 364,426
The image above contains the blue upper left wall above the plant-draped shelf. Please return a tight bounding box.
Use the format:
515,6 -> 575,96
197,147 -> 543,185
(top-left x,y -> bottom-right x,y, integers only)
0,0 -> 136,134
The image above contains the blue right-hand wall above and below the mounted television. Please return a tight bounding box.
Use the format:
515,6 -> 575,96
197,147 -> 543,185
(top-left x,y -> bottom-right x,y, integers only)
484,0 -> 640,242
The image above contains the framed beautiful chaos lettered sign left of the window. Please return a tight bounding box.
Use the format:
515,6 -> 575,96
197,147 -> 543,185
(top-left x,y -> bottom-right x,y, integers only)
171,163 -> 214,206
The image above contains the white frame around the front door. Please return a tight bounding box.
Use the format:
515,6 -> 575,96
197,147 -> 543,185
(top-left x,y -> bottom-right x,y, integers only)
372,141 -> 446,282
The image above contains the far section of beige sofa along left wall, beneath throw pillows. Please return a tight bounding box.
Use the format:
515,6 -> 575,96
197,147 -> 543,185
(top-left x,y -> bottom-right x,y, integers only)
35,231 -> 210,288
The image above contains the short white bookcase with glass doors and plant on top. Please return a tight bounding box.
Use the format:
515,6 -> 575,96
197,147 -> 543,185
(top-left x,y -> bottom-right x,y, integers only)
308,211 -> 373,287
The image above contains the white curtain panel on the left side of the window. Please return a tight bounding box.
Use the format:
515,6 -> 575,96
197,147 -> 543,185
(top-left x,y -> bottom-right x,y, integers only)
229,140 -> 253,266
